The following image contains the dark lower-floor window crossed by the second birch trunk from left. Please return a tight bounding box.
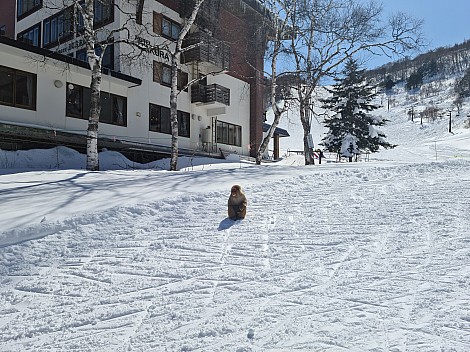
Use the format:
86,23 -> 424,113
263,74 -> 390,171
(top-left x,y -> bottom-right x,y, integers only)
149,104 -> 190,138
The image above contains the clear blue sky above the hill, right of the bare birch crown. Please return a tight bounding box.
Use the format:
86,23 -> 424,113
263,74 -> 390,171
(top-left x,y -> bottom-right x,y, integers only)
367,0 -> 470,68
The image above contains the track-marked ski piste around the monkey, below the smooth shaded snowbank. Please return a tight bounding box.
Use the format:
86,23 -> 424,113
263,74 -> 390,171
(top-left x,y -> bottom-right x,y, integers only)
0,161 -> 470,352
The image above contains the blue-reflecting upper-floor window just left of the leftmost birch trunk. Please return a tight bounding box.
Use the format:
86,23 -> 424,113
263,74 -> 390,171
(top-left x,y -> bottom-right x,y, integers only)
42,7 -> 73,47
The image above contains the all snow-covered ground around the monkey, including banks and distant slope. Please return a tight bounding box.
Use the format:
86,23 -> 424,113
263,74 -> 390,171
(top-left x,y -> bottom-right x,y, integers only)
0,80 -> 470,352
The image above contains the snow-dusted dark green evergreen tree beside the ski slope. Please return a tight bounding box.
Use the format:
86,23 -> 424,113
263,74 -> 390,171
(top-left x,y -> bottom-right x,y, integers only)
321,59 -> 394,161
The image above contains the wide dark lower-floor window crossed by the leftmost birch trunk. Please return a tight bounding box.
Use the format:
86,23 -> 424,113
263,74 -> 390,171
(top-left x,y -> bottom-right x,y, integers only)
66,83 -> 127,127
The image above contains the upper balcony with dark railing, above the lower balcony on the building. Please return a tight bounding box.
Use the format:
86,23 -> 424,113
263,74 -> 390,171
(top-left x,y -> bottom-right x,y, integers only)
181,32 -> 231,70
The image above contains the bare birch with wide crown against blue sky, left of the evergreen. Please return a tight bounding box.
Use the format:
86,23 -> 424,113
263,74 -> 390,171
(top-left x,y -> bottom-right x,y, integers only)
280,0 -> 424,165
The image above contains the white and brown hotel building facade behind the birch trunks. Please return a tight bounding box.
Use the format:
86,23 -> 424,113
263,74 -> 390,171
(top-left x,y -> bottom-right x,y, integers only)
0,0 -> 270,160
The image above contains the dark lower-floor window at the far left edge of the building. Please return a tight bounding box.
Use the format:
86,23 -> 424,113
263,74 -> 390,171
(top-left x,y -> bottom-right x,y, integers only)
0,66 -> 36,110
